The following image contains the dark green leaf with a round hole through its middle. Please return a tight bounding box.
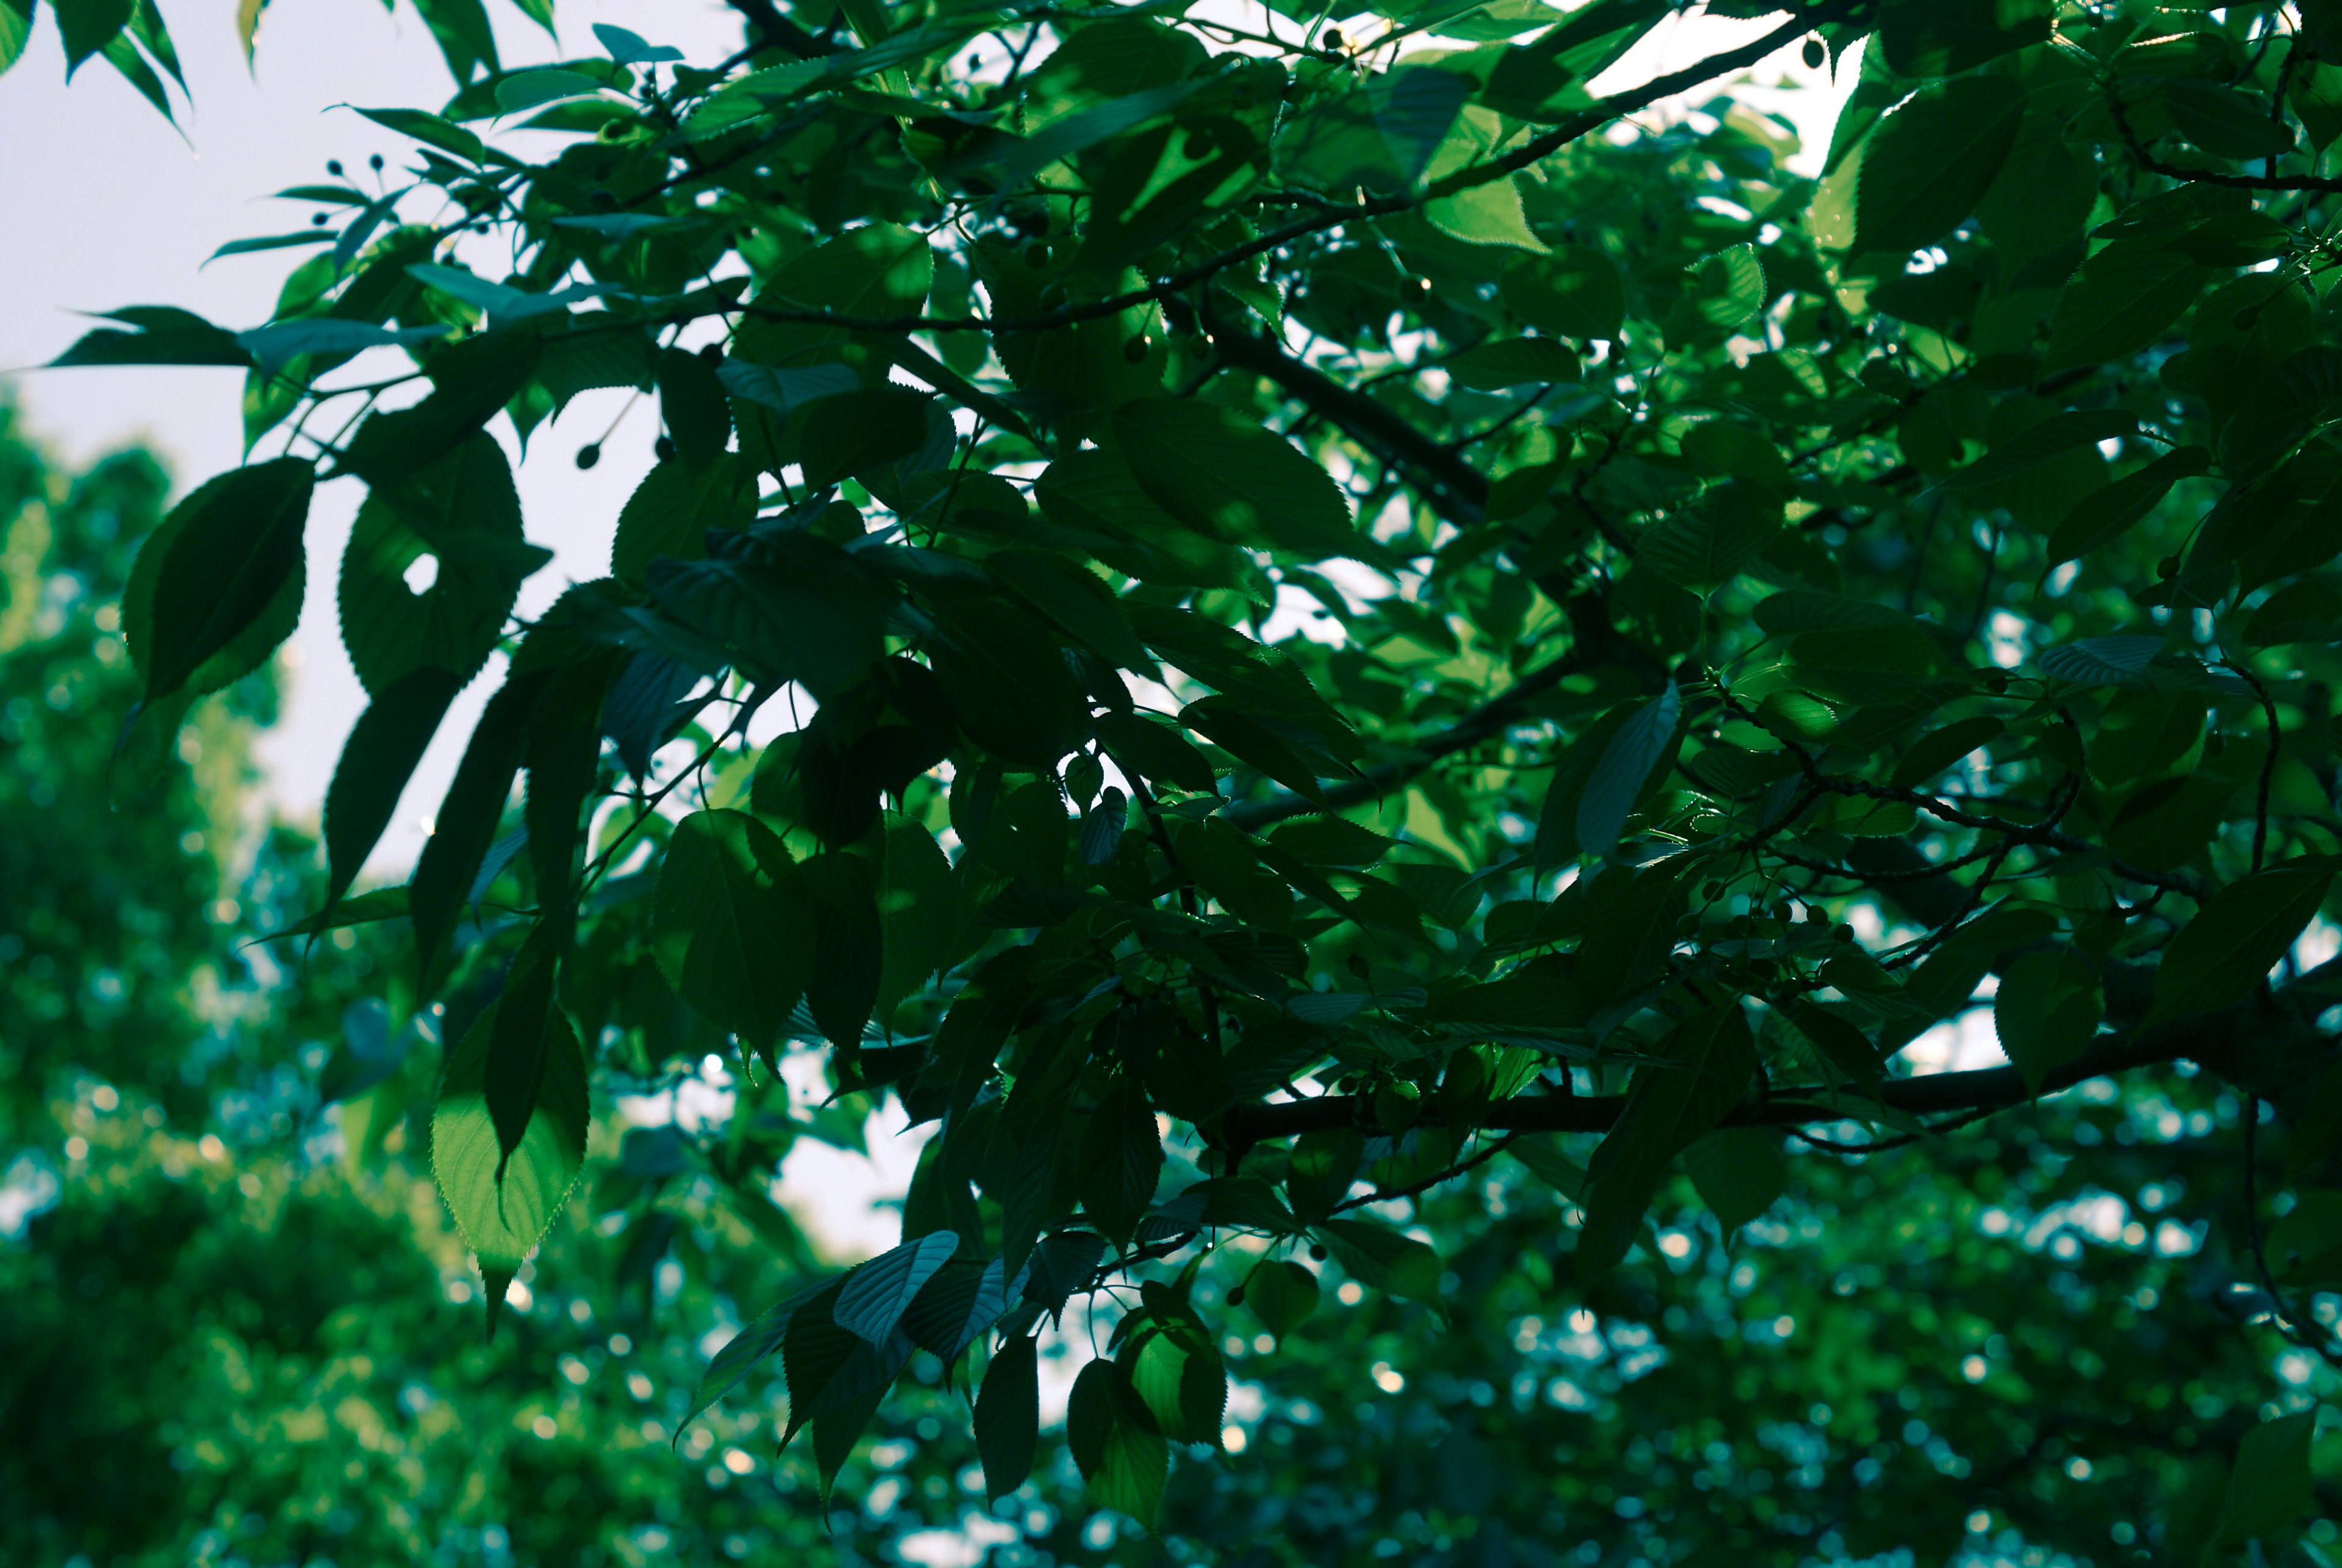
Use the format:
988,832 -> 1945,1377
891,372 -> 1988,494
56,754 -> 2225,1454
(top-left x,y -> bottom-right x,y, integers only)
337,435 -> 553,693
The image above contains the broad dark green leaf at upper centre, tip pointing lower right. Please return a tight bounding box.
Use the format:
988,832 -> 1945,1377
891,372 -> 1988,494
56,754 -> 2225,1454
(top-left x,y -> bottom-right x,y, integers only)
1115,398 -> 1372,559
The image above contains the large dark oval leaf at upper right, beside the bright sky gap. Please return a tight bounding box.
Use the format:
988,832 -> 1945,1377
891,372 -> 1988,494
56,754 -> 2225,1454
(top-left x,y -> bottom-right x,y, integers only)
1852,77 -> 2026,257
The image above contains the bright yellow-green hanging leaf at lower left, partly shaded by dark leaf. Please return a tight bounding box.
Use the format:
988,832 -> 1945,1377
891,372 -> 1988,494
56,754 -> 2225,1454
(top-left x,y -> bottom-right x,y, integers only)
431,1001 -> 588,1325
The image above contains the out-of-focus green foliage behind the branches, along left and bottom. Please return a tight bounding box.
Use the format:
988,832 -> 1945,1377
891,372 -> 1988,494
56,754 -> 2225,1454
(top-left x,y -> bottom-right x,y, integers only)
0,412 -> 2342,1568
